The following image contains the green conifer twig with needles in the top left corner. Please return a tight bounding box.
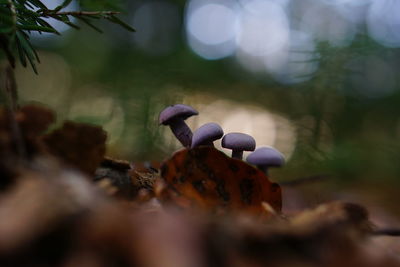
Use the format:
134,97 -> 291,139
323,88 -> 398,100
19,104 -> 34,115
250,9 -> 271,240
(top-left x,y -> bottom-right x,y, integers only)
0,0 -> 135,73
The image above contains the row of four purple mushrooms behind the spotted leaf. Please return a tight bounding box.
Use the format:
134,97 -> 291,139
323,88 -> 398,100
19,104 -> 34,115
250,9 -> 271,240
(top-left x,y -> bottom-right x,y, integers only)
159,104 -> 285,174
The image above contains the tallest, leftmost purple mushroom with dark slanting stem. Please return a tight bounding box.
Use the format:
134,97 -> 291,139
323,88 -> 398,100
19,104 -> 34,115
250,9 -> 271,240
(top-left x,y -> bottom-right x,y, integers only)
158,104 -> 199,147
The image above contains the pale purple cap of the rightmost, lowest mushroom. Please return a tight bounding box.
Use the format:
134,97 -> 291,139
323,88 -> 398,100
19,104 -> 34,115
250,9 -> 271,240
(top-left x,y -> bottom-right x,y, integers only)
246,147 -> 285,167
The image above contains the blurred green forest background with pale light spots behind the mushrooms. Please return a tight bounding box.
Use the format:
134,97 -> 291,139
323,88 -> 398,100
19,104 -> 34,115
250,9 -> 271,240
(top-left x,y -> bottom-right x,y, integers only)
8,0 -> 400,214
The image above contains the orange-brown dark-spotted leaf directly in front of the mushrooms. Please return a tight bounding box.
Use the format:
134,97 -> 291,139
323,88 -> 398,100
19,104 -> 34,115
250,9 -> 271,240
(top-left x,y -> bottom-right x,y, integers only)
161,147 -> 282,217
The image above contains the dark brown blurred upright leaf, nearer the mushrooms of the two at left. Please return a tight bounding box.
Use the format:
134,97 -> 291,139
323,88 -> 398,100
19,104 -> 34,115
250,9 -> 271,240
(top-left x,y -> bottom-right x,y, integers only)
44,121 -> 107,174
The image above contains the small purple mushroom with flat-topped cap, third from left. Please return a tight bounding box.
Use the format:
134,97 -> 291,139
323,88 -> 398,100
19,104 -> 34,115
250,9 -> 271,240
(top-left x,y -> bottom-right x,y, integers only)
221,133 -> 256,159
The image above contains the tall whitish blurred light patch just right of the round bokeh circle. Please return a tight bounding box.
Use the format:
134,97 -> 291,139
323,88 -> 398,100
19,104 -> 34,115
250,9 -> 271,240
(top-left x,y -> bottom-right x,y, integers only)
236,0 -> 290,76
